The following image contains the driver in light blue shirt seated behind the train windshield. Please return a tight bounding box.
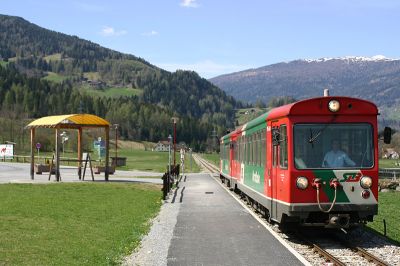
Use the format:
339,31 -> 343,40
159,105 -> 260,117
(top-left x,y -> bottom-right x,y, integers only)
322,139 -> 356,168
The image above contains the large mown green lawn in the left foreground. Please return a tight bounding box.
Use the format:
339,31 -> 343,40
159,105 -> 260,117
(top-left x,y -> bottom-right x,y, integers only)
0,183 -> 161,265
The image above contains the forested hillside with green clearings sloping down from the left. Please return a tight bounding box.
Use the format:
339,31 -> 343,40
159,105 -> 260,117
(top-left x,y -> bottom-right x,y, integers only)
0,15 -> 241,149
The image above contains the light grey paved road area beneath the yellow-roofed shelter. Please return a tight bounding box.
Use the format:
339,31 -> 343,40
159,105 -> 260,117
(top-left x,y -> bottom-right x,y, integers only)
0,162 -> 163,184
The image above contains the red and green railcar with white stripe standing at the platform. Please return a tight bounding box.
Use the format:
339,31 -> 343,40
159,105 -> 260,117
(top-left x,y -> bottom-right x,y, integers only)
220,96 -> 390,227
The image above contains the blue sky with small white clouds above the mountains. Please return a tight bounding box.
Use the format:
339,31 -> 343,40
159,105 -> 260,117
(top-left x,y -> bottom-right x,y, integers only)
0,0 -> 400,78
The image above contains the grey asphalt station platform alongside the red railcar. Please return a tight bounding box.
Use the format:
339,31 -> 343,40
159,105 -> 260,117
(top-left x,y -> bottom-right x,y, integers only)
167,174 -> 302,265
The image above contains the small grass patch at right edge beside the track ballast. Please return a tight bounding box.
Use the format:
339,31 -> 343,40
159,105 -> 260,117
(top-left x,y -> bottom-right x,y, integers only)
367,192 -> 400,244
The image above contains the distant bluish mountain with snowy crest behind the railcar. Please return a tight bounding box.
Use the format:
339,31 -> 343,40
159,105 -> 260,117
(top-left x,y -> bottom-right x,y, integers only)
210,56 -> 400,118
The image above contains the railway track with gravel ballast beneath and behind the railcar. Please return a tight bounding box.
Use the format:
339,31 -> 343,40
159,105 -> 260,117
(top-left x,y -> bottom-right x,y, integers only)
195,155 -> 392,266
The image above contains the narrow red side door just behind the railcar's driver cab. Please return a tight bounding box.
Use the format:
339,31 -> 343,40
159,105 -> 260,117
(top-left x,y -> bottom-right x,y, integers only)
270,122 -> 279,220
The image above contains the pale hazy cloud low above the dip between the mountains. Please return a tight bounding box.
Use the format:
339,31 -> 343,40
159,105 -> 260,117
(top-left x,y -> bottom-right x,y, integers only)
156,60 -> 252,78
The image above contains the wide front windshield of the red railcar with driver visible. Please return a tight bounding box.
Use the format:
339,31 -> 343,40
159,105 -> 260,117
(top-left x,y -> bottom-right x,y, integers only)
293,124 -> 374,169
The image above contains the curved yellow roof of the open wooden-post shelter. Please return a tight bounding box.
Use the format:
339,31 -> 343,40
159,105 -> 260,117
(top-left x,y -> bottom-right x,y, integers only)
26,114 -> 110,128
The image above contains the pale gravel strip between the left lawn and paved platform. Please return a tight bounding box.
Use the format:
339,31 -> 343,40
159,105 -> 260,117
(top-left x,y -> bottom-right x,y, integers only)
122,190 -> 180,266
